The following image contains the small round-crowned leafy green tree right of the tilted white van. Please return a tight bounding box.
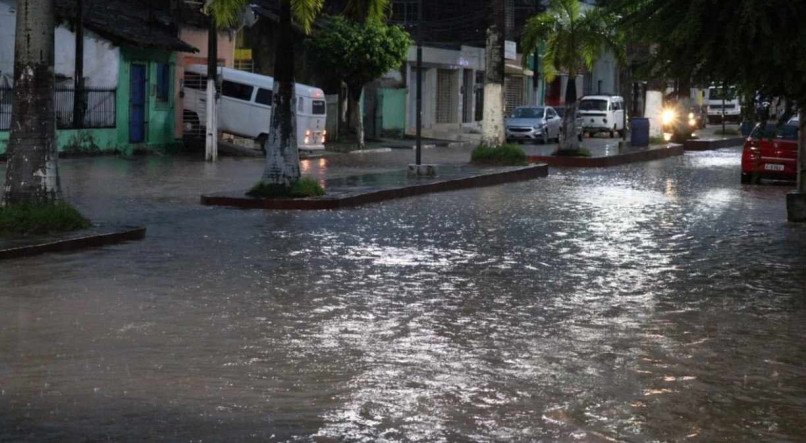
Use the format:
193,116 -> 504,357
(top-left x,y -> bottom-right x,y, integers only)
308,16 -> 411,149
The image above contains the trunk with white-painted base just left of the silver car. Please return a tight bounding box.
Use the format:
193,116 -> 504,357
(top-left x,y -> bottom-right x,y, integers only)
481,0 -> 506,146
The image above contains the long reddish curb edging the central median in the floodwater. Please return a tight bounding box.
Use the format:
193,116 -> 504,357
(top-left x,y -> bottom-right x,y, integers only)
201,164 -> 548,210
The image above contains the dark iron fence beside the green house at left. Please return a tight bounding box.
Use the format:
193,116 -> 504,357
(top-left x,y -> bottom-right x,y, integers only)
0,88 -> 117,131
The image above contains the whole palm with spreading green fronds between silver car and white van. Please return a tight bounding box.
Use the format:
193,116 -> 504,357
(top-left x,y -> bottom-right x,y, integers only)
521,0 -> 623,150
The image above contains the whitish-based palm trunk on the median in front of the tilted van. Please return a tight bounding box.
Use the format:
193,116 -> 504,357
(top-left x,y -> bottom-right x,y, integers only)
262,1 -> 300,188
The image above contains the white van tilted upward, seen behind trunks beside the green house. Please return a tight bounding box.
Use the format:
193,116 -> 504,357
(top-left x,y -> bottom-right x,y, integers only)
182,65 -> 327,151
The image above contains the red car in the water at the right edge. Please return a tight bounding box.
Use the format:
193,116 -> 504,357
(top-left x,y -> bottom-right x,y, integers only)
742,117 -> 799,183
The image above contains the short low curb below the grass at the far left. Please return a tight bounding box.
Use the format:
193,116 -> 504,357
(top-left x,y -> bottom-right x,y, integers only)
0,227 -> 146,260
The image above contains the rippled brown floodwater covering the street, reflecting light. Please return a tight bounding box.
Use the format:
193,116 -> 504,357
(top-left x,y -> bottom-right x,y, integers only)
0,148 -> 806,442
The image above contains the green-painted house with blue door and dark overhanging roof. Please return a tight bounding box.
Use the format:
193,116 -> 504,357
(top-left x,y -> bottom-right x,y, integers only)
0,0 -> 195,154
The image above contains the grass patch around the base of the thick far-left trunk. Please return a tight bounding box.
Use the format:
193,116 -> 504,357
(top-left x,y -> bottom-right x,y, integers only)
0,202 -> 90,237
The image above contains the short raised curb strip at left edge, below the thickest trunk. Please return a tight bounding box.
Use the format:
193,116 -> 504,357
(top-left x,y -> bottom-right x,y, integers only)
0,227 -> 146,260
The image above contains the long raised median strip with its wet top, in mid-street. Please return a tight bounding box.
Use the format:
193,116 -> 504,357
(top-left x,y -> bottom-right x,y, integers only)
201,164 -> 548,210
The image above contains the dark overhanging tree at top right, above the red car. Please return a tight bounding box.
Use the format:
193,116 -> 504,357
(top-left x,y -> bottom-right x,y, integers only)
612,0 -> 806,212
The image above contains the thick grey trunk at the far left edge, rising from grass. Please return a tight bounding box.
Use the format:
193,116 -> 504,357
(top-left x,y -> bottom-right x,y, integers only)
4,0 -> 61,204
